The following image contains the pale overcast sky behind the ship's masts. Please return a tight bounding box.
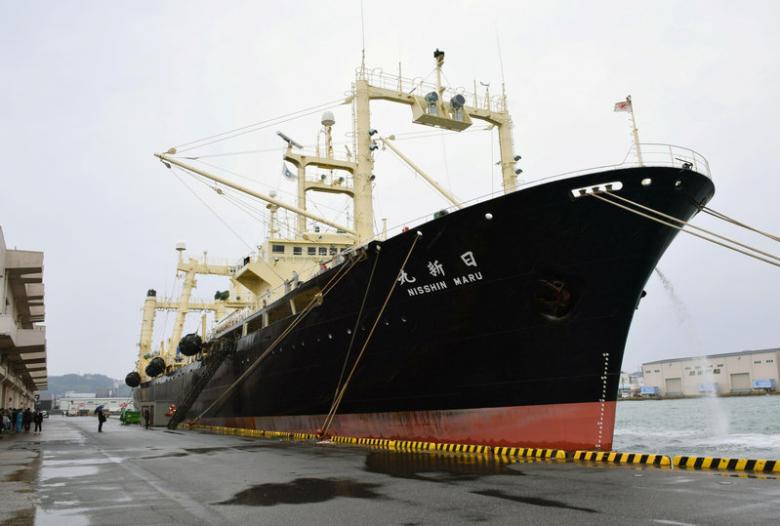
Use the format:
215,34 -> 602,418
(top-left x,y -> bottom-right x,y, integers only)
0,0 -> 780,378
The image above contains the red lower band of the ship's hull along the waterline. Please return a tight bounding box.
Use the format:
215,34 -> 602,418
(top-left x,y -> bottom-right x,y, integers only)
202,402 -> 615,451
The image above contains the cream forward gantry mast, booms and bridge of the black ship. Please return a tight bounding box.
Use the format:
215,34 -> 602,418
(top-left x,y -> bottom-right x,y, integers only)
155,49 -> 521,322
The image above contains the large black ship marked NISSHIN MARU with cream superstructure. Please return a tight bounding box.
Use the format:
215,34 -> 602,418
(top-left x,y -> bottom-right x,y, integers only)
127,50 -> 714,450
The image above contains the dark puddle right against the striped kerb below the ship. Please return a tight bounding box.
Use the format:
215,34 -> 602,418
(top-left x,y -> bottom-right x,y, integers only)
364,451 -> 524,482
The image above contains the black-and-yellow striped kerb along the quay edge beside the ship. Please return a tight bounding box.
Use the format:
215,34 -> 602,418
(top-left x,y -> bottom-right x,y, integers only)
190,423 -> 780,478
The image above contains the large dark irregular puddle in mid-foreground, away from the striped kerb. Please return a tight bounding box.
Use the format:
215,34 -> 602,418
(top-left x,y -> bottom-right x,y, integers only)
217,478 -> 382,506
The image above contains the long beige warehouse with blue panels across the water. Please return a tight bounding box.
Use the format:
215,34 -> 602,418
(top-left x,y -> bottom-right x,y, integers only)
642,349 -> 780,398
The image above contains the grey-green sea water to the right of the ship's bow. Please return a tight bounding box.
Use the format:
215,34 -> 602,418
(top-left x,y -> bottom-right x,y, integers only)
612,395 -> 780,459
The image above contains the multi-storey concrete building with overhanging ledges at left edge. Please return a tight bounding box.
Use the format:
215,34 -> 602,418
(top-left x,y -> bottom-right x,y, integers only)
0,228 -> 48,409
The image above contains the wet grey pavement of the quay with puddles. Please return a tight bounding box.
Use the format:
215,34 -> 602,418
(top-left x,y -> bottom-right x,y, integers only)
0,416 -> 780,526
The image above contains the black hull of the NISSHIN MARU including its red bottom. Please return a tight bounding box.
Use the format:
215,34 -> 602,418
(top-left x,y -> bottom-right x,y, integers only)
135,167 -> 714,450
